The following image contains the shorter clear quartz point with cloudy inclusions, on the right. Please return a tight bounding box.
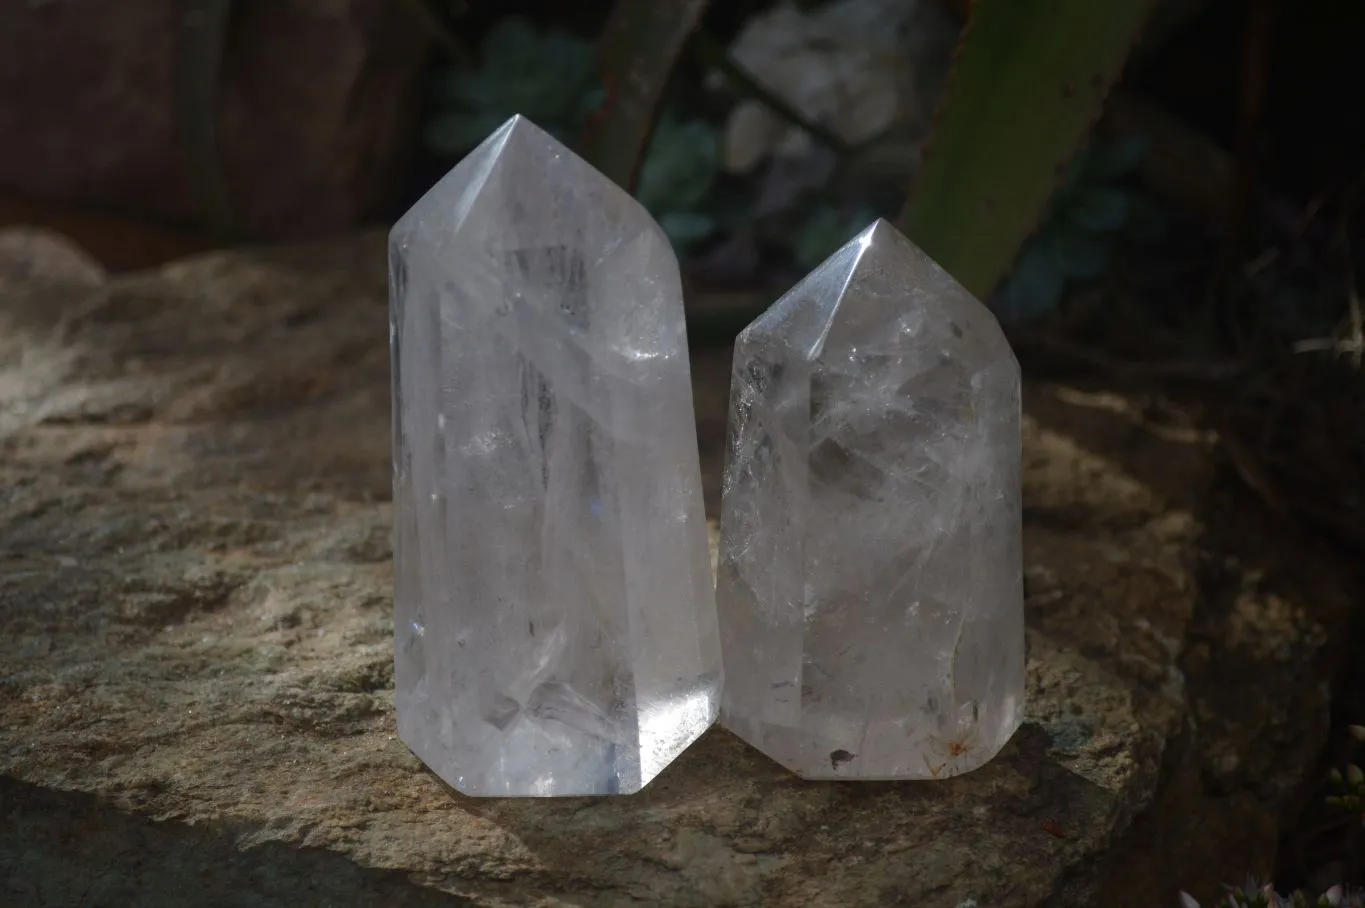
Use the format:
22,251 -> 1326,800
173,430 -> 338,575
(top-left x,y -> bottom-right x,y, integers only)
717,221 -> 1024,780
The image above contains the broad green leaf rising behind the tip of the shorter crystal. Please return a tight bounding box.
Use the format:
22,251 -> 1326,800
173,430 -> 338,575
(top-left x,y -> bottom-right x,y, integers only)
898,0 -> 1153,298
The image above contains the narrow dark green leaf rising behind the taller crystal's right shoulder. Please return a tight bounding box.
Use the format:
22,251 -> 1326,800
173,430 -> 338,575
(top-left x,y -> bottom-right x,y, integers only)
580,0 -> 707,190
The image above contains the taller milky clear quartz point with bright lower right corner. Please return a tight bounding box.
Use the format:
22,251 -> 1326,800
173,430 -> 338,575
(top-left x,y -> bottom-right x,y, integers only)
389,117 -> 721,796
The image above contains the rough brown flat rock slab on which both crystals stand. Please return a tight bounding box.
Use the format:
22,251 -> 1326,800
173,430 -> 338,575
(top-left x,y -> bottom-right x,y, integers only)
0,228 -> 1350,908
